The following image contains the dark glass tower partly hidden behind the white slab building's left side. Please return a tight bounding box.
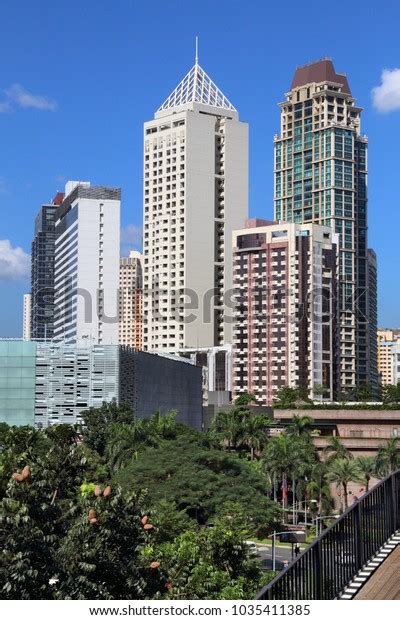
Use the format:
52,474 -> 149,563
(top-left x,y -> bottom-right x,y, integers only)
31,192 -> 64,340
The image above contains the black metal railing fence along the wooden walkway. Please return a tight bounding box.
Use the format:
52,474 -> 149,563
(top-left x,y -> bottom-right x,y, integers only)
257,470 -> 400,600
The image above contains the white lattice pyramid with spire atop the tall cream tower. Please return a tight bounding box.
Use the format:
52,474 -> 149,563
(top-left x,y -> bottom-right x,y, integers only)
157,47 -> 236,112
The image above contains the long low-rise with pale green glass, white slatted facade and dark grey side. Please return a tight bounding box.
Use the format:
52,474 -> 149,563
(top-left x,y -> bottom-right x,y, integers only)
0,340 -> 202,429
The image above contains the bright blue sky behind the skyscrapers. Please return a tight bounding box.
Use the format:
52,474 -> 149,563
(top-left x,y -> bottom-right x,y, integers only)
0,0 -> 400,336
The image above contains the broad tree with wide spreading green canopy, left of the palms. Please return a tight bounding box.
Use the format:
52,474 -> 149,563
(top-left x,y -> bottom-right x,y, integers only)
114,434 -> 280,532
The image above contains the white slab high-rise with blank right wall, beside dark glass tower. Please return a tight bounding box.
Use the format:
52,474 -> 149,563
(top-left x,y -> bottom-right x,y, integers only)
54,181 -> 121,344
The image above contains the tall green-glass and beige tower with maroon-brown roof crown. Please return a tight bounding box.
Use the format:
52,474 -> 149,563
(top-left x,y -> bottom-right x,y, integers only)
275,60 -> 377,391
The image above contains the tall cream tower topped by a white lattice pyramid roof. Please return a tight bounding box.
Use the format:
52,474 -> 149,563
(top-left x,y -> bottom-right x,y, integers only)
144,54 -> 248,352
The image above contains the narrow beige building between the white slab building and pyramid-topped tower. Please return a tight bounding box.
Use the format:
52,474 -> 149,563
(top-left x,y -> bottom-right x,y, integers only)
118,251 -> 143,351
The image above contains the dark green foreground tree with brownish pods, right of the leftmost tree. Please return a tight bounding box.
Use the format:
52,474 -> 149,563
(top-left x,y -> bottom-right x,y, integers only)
56,486 -> 166,600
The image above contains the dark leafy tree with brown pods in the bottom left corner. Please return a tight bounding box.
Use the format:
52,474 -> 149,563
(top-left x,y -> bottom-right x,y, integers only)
0,425 -> 94,600
